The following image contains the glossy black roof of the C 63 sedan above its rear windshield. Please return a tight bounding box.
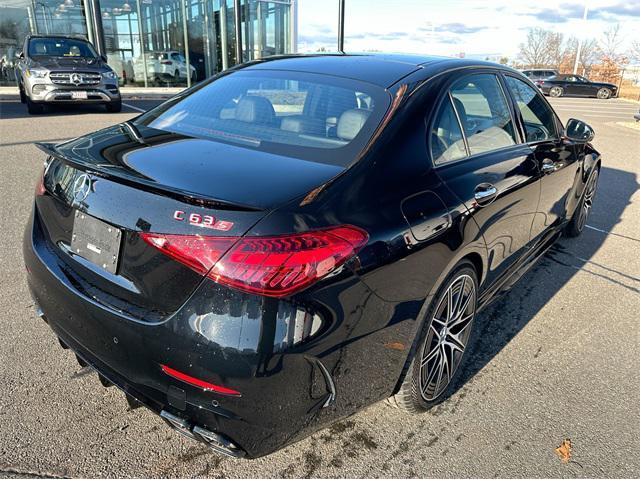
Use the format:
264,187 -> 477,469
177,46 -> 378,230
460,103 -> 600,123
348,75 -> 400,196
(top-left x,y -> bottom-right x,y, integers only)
243,53 -> 460,88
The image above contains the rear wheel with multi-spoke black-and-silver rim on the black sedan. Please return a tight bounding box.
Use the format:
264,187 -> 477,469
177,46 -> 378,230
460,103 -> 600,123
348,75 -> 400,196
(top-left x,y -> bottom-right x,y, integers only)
388,261 -> 478,414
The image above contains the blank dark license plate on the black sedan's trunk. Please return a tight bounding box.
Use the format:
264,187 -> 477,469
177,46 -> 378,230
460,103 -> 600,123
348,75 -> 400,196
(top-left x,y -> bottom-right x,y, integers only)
71,211 -> 122,274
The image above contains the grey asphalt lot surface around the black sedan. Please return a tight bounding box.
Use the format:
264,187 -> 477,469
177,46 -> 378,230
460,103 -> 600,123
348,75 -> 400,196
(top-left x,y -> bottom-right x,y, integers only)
0,98 -> 640,478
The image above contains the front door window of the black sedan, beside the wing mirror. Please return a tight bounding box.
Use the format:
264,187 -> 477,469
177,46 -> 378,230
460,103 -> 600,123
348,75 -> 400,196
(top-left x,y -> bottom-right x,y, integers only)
506,76 -> 557,143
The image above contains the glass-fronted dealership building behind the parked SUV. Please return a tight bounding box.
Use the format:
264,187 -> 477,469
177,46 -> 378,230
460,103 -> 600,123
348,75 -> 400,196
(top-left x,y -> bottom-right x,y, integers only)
0,0 -> 297,87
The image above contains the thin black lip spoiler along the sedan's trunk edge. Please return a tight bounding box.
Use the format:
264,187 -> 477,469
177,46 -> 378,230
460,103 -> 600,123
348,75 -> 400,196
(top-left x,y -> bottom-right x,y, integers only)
34,142 -> 264,212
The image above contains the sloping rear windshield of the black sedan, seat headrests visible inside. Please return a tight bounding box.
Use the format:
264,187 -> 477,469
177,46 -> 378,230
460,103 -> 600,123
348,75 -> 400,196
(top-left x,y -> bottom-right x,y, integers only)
136,70 -> 390,166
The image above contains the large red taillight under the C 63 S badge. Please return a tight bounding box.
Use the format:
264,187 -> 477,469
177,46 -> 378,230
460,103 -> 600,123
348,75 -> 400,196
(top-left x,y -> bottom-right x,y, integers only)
141,226 -> 368,297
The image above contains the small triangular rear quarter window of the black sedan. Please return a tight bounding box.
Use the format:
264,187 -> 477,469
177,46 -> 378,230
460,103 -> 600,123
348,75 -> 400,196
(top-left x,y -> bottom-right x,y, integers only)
431,98 -> 467,164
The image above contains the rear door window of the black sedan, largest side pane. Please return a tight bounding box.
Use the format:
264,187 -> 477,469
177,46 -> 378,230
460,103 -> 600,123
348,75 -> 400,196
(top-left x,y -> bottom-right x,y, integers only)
451,74 -> 516,155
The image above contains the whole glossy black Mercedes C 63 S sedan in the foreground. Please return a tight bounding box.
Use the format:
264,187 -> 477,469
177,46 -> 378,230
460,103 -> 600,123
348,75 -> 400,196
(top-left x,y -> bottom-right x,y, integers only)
24,54 -> 600,457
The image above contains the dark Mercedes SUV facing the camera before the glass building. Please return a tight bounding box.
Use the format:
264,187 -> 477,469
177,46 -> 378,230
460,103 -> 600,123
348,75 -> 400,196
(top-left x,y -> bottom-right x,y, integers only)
16,35 -> 122,115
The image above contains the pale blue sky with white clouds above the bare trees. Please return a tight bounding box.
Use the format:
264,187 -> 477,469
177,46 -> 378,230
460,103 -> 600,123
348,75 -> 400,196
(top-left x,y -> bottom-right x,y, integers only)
298,0 -> 640,58
